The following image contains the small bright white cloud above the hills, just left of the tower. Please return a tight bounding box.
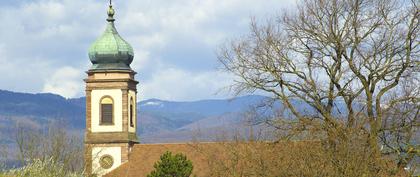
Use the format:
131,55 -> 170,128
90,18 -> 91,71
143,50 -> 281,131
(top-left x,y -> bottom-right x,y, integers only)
43,67 -> 84,98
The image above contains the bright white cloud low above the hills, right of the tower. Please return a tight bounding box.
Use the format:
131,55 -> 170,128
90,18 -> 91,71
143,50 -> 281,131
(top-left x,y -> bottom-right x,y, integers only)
139,68 -> 232,101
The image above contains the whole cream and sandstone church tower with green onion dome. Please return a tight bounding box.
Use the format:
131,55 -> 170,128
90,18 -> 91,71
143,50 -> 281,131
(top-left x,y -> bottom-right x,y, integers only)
85,3 -> 138,176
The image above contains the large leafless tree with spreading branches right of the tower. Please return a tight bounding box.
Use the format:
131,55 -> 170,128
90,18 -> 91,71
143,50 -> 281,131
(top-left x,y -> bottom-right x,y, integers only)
219,0 -> 420,171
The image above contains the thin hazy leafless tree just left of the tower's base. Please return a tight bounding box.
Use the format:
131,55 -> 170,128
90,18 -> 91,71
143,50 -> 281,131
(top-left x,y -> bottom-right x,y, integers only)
16,123 -> 84,172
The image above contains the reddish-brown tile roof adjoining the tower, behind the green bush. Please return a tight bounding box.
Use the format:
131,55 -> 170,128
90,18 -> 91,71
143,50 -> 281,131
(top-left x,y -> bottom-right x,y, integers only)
105,142 -> 316,177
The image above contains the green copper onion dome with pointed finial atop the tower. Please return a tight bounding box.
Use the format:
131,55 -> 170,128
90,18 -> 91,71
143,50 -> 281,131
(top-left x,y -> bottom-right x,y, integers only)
89,5 -> 134,70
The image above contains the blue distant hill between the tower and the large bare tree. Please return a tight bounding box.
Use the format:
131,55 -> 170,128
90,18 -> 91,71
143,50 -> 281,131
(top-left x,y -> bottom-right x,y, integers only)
138,95 -> 267,143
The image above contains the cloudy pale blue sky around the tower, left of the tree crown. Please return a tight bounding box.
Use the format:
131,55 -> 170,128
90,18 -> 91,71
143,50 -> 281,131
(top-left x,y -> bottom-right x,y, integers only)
0,0 -> 296,101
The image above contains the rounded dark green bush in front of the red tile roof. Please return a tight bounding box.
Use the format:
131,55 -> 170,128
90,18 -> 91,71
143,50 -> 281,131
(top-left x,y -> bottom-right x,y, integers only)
147,151 -> 193,177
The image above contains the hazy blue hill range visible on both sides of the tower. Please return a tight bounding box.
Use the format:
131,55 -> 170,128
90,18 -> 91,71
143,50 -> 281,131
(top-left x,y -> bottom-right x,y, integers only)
0,90 -> 266,144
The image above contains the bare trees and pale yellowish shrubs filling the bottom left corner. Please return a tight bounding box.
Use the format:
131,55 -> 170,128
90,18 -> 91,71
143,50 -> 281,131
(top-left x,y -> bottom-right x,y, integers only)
0,123 -> 84,177
